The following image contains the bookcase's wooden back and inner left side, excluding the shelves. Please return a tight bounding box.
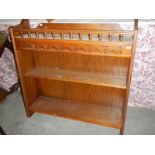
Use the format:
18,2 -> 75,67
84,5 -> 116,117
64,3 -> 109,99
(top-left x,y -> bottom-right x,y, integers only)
17,50 -> 129,108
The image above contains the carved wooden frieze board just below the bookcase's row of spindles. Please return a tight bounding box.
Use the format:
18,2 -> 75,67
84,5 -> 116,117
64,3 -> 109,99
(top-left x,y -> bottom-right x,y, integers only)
16,40 -> 131,55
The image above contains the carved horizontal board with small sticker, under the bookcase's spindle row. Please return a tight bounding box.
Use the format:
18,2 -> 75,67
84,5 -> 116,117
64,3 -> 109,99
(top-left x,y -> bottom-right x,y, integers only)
16,38 -> 132,58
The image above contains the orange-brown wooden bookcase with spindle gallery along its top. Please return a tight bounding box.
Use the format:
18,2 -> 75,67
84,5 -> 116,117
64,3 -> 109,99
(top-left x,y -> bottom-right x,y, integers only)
10,20 -> 138,134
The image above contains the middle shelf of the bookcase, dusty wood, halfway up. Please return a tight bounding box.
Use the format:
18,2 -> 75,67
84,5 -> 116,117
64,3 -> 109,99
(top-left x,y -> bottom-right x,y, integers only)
25,67 -> 126,89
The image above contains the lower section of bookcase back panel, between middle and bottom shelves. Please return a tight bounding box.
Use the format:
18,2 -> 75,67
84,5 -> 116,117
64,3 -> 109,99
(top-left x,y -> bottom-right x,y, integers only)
38,79 -> 126,108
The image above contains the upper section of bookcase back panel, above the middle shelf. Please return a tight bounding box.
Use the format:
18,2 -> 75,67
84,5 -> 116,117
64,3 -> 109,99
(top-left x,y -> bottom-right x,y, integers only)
18,50 -> 130,78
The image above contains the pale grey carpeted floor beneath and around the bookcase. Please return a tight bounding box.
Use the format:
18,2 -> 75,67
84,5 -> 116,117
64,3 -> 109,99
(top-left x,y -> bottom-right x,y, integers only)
0,91 -> 155,135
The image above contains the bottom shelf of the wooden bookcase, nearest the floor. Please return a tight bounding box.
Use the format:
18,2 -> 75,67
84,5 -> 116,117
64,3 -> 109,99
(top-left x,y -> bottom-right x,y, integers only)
30,96 -> 122,129
